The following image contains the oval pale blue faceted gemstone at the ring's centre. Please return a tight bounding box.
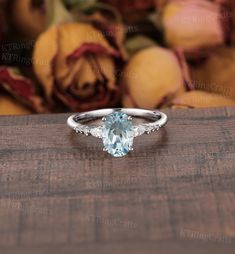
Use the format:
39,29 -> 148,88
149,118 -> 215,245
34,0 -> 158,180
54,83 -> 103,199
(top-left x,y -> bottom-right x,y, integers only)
102,111 -> 134,157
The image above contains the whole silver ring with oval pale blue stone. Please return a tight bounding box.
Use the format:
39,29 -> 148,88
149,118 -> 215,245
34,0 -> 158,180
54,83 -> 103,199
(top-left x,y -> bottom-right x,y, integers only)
67,108 -> 167,157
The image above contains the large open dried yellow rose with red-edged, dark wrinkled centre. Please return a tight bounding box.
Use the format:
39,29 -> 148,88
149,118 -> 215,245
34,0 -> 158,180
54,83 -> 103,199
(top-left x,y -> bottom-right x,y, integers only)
33,23 -> 125,111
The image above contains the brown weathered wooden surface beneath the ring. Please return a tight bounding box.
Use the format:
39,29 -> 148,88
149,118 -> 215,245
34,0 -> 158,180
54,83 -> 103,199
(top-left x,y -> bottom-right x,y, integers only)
0,108 -> 235,254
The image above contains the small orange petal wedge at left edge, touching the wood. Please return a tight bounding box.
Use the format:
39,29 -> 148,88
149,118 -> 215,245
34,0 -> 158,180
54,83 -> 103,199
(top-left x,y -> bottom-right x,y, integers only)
0,95 -> 32,115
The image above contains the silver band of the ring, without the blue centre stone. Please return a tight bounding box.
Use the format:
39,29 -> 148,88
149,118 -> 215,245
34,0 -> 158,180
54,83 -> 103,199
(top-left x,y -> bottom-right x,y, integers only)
67,108 -> 167,137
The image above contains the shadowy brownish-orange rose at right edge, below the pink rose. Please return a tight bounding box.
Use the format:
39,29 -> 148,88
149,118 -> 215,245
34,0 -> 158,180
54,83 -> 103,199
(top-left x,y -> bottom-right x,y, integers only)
191,47 -> 235,99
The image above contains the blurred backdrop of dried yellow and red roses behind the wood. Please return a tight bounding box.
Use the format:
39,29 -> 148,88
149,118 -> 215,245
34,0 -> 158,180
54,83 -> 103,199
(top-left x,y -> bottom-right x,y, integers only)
0,0 -> 235,115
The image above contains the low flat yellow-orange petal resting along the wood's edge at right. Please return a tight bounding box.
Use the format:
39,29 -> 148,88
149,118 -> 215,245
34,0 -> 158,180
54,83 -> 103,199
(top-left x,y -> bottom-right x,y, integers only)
172,91 -> 235,109
